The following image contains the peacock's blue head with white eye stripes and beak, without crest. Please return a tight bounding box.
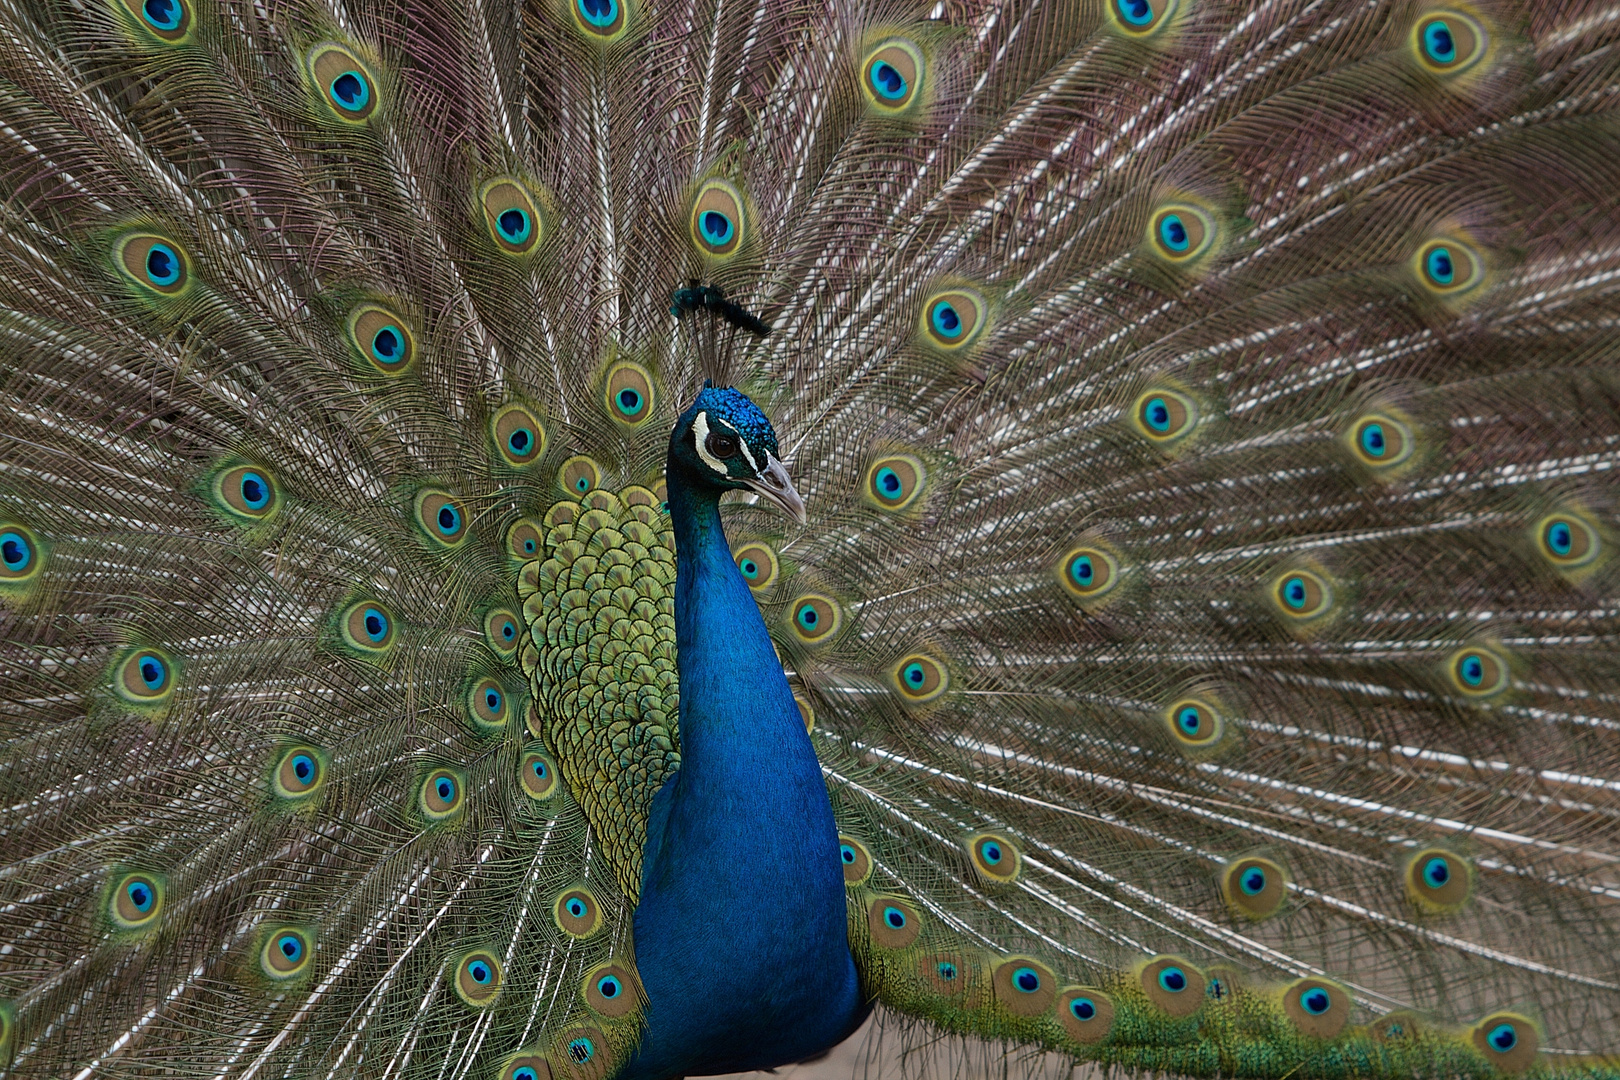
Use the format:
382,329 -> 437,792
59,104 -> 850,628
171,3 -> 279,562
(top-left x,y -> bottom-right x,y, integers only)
669,384 -> 805,525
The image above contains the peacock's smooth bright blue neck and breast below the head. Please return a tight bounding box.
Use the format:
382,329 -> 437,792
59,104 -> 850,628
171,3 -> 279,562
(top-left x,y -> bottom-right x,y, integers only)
620,465 -> 867,1080
